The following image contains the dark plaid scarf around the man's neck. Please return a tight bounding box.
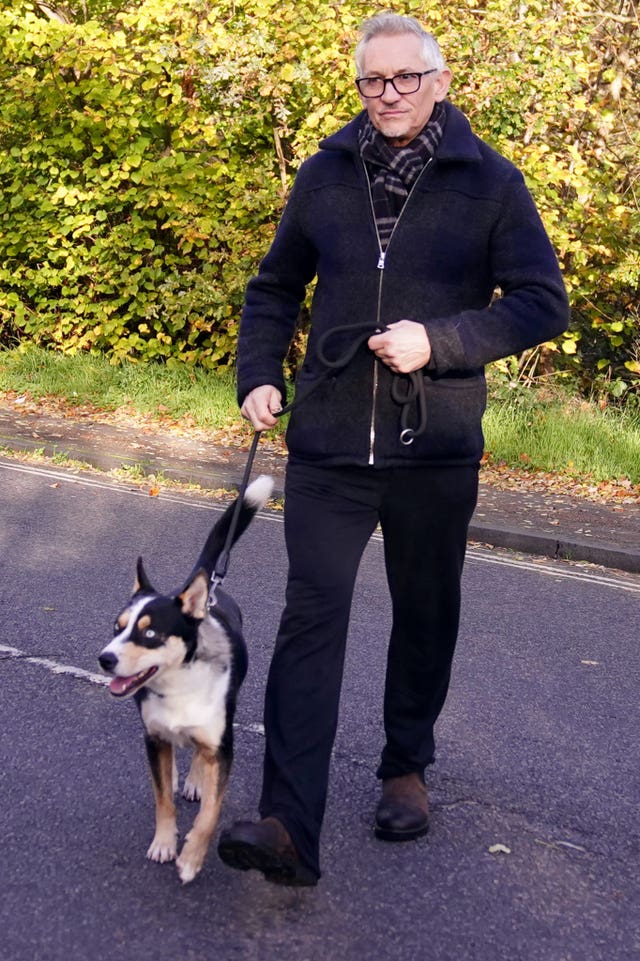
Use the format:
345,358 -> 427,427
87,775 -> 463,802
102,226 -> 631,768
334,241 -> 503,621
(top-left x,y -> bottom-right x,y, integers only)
359,103 -> 446,250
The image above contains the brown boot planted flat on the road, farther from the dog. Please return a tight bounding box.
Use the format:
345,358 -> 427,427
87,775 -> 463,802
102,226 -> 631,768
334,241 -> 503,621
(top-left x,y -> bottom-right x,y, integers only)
375,772 -> 429,841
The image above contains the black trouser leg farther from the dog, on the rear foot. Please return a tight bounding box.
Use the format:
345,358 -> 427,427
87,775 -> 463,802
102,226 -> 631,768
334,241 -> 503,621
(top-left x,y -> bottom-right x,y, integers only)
378,467 -> 478,779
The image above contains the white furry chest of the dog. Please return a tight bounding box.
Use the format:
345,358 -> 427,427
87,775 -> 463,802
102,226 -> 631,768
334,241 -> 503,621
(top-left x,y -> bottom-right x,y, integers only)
141,661 -> 230,748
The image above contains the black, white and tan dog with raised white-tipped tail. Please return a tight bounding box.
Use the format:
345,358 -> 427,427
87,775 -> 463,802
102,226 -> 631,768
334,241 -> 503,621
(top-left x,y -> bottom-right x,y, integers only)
98,476 -> 273,884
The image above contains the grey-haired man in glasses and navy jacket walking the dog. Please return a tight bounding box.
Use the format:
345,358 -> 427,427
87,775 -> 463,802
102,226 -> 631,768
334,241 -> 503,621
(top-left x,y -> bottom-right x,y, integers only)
219,14 -> 568,885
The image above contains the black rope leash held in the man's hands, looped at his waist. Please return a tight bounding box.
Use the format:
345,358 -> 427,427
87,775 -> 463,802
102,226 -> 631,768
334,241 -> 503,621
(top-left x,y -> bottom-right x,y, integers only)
209,323 -> 427,606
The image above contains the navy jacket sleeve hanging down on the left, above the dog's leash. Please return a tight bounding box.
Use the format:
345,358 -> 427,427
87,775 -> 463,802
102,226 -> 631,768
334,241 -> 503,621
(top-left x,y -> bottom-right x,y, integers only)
237,172 -> 317,404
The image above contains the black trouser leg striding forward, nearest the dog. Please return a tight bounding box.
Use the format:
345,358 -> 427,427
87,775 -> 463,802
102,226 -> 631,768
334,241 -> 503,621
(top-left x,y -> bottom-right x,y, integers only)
260,465 -> 378,873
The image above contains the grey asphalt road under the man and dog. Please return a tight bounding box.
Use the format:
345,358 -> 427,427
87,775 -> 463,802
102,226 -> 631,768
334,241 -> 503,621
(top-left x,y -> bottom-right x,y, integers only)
0,461 -> 640,961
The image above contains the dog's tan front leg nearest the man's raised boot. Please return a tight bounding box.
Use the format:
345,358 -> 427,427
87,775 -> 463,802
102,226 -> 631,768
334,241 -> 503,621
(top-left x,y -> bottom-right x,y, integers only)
177,747 -> 231,884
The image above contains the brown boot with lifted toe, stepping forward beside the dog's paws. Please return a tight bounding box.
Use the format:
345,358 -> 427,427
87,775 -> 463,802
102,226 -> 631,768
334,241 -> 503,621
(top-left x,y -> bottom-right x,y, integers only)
218,817 -> 318,887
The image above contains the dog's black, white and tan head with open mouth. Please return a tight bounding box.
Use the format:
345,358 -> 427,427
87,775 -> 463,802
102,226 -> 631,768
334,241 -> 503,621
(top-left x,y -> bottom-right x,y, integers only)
98,559 -> 209,697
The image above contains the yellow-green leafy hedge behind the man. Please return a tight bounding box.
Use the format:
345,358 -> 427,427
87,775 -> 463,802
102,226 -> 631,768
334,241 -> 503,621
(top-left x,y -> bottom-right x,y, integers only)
0,0 -> 640,394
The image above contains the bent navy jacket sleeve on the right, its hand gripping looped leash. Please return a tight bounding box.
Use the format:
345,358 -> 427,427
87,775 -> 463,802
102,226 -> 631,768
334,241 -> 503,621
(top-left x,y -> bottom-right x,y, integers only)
426,168 -> 569,375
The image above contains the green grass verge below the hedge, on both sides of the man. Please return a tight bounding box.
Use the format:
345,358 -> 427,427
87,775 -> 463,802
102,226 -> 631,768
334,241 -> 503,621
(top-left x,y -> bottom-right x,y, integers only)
0,347 -> 640,486
